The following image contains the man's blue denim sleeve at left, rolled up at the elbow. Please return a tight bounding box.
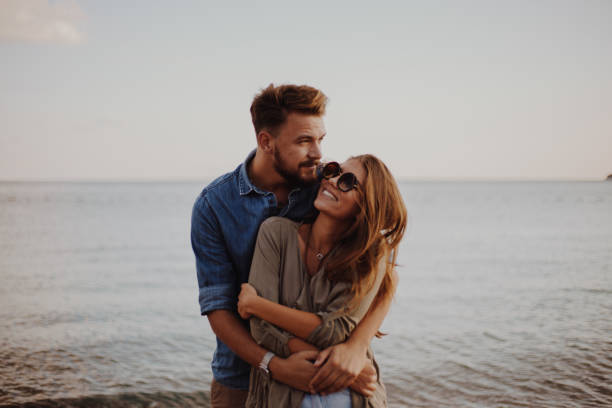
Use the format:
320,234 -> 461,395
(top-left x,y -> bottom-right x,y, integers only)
191,195 -> 238,315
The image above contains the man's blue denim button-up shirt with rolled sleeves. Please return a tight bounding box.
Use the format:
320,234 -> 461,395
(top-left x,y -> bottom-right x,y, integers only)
191,151 -> 318,389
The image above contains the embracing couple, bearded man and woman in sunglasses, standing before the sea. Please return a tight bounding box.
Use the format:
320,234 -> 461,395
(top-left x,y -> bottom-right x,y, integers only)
191,85 -> 407,408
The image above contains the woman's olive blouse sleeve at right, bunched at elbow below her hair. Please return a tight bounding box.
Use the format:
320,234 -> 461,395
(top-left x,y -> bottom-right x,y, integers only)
306,257 -> 386,349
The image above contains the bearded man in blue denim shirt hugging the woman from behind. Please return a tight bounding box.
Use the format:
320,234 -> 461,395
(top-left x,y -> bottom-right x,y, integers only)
191,85 -> 389,407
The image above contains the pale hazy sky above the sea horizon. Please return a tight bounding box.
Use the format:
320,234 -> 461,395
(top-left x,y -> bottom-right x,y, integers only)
0,0 -> 612,180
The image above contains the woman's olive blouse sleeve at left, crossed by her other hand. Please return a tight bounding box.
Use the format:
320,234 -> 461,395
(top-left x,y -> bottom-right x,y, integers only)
249,219 -> 293,357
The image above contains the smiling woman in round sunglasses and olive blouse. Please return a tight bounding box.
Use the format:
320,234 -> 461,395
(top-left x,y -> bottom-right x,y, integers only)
238,155 -> 407,408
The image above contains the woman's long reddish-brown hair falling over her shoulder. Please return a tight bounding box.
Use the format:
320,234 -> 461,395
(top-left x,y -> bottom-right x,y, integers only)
325,154 -> 408,307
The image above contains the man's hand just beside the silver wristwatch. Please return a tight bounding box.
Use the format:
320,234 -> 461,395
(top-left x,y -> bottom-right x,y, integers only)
269,351 -> 319,392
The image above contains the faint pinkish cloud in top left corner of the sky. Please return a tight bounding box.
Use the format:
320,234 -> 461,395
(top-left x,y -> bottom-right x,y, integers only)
0,0 -> 85,44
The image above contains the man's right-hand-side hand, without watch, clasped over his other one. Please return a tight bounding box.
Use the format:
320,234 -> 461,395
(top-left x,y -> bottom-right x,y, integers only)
310,342 -> 368,395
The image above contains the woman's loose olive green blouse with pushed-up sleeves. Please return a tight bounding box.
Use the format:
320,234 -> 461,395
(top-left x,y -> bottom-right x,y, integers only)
246,217 -> 387,408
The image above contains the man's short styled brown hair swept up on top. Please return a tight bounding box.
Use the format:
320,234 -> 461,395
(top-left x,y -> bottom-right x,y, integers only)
251,84 -> 327,133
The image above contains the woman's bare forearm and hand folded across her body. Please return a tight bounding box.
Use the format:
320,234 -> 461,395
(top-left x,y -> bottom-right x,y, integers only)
238,283 -> 322,340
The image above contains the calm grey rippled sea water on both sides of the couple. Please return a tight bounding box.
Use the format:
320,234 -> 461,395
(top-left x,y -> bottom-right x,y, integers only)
0,182 -> 612,407
